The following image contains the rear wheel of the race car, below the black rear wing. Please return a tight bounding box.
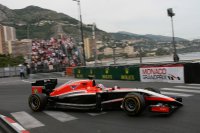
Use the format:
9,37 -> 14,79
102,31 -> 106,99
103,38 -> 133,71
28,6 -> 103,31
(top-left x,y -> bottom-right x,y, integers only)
28,94 -> 47,112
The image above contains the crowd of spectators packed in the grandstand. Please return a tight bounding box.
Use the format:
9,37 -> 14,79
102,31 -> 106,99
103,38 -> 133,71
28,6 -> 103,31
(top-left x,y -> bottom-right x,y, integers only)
31,37 -> 81,70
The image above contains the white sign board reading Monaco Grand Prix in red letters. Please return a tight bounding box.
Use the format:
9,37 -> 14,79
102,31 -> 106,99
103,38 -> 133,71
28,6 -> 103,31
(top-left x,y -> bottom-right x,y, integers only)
140,64 -> 184,83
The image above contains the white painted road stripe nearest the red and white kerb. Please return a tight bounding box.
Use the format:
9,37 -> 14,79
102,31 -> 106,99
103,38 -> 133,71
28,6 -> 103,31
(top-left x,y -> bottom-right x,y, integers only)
11,111 -> 44,129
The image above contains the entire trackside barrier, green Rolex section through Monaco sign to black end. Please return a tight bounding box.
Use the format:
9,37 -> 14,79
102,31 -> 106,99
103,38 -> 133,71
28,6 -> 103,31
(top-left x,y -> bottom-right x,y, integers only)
74,62 -> 200,83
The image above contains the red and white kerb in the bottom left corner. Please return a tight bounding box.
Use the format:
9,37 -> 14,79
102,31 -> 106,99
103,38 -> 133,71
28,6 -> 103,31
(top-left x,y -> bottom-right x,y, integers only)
0,115 -> 30,133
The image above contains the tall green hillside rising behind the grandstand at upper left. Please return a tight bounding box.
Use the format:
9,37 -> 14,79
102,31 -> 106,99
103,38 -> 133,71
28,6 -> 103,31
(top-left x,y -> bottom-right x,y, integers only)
0,5 -> 109,41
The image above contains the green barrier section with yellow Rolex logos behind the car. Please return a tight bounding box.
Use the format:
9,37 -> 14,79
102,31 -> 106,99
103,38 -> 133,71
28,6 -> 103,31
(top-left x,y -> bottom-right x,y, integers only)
74,65 -> 140,81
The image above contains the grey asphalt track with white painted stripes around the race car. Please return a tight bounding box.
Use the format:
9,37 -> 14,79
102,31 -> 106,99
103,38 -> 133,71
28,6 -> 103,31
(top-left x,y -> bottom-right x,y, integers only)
0,77 -> 200,133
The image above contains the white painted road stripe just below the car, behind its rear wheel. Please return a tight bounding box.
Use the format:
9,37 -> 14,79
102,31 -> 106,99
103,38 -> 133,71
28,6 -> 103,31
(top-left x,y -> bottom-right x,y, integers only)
43,111 -> 78,122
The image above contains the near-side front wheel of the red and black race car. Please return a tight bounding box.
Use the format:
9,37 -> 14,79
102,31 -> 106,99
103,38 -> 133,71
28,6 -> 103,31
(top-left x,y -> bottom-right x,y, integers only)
122,93 -> 145,116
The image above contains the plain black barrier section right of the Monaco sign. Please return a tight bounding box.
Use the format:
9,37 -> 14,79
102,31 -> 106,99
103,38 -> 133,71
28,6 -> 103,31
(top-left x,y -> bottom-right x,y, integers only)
184,63 -> 200,83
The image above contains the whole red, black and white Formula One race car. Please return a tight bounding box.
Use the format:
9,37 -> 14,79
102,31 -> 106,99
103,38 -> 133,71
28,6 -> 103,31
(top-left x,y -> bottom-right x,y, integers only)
29,79 -> 183,116
